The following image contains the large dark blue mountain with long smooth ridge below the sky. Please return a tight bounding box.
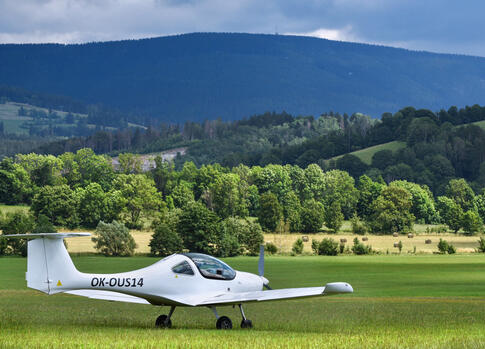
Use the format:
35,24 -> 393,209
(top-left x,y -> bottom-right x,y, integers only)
0,33 -> 485,122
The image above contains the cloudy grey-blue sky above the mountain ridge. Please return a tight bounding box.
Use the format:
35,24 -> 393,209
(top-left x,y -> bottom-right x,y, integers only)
0,0 -> 485,57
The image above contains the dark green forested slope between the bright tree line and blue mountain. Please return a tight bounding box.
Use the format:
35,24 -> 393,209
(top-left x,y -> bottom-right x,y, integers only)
37,105 -> 485,195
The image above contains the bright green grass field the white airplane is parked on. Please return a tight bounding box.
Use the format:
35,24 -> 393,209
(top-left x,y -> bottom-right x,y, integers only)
0,254 -> 485,348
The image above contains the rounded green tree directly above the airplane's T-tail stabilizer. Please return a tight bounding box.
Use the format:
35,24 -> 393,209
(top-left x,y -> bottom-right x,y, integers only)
30,184 -> 79,228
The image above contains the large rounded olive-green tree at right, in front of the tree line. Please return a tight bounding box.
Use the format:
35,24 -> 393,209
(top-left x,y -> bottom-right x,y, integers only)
366,186 -> 414,234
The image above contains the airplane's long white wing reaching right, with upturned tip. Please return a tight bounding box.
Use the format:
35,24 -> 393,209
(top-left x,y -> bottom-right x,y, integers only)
197,282 -> 353,306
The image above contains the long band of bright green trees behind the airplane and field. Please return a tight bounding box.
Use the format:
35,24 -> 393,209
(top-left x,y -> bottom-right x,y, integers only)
0,149 -> 485,255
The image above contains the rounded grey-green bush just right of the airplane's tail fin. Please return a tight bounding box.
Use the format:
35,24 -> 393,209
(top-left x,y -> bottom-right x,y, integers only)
91,221 -> 136,256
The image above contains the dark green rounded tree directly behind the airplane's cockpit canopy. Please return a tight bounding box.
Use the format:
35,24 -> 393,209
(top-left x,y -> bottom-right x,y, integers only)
177,202 -> 220,254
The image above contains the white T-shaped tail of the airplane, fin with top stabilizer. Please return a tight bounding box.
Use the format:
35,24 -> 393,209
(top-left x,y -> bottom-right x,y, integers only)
3,233 -> 91,294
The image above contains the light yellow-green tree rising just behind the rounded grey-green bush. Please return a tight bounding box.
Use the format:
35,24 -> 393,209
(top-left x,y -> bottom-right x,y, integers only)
113,174 -> 162,228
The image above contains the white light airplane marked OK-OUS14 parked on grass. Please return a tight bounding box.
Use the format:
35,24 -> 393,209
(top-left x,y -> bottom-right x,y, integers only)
0,233 -> 353,329
